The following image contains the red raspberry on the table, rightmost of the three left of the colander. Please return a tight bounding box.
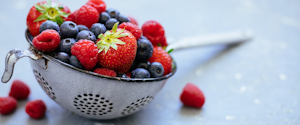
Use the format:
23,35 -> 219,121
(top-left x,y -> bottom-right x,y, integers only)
25,100 -> 46,119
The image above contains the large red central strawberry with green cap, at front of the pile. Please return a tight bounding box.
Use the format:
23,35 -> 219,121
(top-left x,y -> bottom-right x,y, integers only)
96,23 -> 137,73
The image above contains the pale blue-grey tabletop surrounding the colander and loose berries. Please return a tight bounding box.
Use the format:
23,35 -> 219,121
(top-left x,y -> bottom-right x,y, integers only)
0,0 -> 300,125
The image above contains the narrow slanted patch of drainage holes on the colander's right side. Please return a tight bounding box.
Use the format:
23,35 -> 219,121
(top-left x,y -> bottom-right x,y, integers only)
121,96 -> 153,115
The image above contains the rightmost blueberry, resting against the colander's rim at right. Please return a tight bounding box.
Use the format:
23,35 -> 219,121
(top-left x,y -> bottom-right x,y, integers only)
147,62 -> 164,78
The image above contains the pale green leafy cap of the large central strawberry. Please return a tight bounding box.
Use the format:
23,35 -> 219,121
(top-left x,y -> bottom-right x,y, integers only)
96,22 -> 128,54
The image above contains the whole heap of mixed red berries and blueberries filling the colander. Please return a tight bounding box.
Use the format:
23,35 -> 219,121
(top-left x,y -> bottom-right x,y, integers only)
27,0 -> 172,78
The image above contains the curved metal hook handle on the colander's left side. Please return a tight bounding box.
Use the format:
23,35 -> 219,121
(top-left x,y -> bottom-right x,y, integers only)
1,48 -> 42,83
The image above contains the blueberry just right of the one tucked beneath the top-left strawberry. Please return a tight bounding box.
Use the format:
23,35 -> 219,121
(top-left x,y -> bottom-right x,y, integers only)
60,21 -> 79,38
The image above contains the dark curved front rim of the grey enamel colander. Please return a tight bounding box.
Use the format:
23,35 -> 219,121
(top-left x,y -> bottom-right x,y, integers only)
25,29 -> 177,83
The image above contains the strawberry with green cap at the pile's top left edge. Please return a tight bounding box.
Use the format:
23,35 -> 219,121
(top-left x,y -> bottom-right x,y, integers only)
26,0 -> 71,36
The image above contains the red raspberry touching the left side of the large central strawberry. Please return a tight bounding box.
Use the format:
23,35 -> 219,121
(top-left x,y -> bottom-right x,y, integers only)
71,39 -> 99,70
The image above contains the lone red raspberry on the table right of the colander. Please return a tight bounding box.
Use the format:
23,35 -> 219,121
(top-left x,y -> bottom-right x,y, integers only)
180,83 -> 205,108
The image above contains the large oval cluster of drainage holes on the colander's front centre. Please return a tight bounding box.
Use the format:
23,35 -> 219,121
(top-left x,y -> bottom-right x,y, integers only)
73,93 -> 113,115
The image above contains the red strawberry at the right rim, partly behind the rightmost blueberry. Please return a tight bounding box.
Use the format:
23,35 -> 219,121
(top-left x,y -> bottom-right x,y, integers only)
148,46 -> 172,75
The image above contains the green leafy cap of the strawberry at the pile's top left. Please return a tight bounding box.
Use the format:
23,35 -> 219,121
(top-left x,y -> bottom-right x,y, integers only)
34,0 -> 70,25
